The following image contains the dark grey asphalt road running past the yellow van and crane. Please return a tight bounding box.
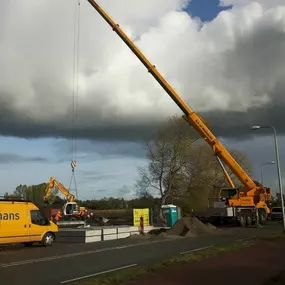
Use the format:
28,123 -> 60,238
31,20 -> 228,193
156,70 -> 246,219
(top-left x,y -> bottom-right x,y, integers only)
0,223 -> 281,285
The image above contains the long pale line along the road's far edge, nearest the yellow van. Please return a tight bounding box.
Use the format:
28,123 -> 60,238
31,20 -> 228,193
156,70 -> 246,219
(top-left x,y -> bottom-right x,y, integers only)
0,236 -> 183,268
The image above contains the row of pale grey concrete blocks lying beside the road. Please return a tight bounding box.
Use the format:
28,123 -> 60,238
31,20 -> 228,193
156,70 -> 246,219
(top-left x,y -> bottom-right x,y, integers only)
56,226 -> 154,243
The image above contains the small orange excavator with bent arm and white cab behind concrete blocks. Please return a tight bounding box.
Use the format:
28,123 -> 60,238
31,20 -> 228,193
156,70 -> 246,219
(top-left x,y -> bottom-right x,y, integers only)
44,176 -> 86,225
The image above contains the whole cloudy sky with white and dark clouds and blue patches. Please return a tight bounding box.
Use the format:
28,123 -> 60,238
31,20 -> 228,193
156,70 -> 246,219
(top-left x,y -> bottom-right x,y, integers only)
0,0 -> 285,199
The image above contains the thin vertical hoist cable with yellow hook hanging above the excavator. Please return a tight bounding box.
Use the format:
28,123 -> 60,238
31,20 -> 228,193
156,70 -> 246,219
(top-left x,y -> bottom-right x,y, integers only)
69,0 -> 80,199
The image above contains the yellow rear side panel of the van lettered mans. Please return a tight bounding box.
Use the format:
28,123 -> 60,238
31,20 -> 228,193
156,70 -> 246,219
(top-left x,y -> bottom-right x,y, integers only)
0,202 -> 29,244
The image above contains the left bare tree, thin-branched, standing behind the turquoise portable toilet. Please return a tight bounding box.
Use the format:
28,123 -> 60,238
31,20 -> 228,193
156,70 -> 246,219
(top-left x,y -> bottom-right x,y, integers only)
137,117 -> 193,205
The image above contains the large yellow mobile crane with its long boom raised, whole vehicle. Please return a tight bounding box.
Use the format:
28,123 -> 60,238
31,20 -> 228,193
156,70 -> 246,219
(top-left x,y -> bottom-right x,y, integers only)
87,0 -> 272,226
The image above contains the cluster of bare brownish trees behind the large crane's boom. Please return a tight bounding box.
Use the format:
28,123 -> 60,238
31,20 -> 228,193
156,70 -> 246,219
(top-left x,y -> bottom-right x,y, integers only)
137,117 -> 251,213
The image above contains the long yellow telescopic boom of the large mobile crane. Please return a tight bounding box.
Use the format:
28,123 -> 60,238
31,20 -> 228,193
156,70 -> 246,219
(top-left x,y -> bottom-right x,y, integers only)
87,0 -> 257,191
